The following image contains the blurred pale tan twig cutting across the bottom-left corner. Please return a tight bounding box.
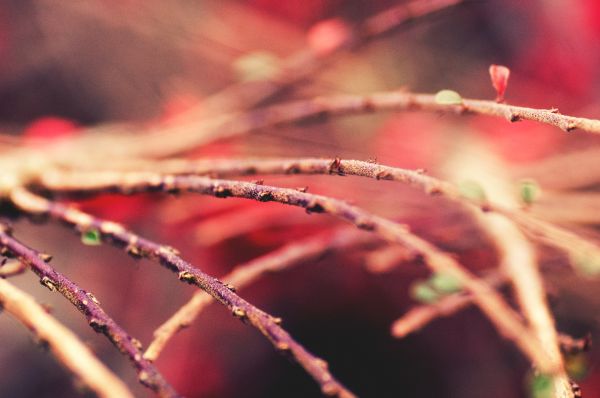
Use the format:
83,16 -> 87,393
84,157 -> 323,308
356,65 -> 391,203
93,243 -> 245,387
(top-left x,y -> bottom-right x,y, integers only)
0,279 -> 133,398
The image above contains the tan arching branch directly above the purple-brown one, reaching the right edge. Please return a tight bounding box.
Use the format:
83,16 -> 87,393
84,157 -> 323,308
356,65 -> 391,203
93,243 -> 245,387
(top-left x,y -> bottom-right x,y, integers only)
39,158 -> 600,276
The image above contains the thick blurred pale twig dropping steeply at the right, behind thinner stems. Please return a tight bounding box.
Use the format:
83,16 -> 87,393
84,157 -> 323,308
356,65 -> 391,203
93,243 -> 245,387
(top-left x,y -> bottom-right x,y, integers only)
446,137 -> 573,398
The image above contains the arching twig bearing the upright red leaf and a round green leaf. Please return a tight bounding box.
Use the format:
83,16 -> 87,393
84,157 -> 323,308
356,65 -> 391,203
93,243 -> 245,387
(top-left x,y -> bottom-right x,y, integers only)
123,90 -> 600,157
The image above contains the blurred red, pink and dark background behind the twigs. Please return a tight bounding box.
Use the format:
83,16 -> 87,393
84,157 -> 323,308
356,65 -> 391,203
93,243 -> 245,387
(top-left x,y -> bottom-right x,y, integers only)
0,0 -> 600,398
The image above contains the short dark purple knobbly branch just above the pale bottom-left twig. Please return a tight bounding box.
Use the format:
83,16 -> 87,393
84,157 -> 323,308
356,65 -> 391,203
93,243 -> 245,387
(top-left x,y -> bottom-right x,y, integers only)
0,224 -> 179,397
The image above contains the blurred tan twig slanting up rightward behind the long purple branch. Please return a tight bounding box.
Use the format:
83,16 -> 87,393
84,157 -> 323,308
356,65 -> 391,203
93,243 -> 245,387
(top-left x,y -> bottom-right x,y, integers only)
144,227 -> 368,361
